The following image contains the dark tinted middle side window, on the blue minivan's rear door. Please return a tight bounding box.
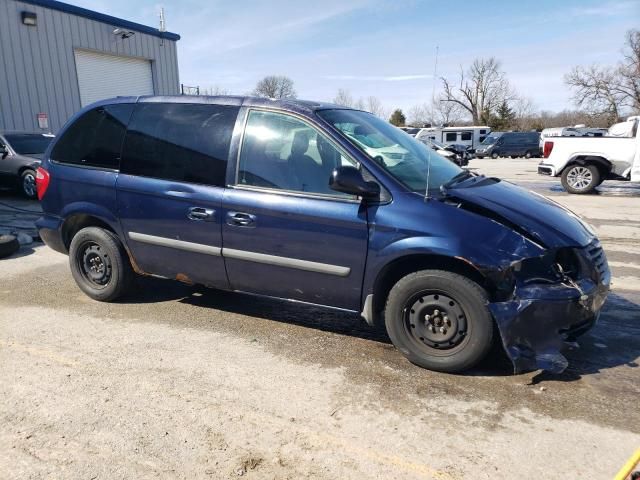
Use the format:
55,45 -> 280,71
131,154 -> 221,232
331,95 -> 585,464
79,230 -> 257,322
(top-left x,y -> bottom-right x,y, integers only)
121,103 -> 239,187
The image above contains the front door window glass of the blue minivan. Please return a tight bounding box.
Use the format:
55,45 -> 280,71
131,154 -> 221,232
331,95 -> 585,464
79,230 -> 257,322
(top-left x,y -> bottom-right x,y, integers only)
237,110 -> 358,196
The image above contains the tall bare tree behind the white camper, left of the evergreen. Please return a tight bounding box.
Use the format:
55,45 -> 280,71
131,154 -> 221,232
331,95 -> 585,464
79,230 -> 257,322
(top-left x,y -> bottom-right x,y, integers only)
442,57 -> 516,125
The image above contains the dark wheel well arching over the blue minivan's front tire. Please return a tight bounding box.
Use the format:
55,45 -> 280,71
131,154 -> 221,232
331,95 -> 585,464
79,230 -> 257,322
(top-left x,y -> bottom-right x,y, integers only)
373,255 -> 487,323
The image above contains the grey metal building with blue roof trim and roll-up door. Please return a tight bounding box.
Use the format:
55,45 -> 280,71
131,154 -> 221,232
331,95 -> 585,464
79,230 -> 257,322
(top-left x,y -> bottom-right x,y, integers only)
0,0 -> 180,133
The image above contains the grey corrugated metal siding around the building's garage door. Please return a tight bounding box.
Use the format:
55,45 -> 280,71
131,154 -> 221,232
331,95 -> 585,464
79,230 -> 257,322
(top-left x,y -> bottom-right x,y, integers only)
0,0 -> 180,132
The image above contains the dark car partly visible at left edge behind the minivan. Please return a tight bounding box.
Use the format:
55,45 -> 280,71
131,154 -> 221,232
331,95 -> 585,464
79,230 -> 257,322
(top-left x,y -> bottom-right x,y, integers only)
0,132 -> 53,198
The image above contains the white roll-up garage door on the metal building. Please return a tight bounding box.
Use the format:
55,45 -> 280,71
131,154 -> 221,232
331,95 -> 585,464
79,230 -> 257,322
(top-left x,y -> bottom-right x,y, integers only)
74,50 -> 153,107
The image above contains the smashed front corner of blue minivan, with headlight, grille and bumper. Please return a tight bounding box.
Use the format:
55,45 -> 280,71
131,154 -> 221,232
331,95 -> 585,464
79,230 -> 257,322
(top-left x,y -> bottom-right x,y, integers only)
489,239 -> 611,373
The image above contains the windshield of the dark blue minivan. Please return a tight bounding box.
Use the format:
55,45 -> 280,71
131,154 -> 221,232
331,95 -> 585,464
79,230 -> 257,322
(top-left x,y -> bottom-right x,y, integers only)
318,110 -> 462,194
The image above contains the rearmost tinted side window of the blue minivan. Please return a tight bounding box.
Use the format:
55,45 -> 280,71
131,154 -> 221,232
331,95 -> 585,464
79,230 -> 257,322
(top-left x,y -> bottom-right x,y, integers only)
51,103 -> 133,170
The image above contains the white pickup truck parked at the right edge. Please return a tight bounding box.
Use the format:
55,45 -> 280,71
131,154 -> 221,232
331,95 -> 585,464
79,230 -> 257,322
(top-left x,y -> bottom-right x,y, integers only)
538,116 -> 640,193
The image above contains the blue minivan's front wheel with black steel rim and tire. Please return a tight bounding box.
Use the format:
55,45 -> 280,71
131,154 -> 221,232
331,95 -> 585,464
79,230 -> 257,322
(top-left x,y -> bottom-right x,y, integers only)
385,270 -> 493,372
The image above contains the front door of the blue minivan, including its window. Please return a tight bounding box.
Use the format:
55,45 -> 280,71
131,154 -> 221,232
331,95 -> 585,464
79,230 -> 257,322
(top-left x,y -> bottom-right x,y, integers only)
222,110 -> 368,310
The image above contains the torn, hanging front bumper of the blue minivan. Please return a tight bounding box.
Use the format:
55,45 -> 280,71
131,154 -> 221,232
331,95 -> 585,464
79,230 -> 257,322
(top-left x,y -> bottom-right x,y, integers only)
489,277 -> 609,373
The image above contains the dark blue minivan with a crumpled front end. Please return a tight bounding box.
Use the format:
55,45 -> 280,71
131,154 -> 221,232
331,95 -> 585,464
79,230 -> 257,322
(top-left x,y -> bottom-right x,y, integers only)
36,96 -> 610,372
